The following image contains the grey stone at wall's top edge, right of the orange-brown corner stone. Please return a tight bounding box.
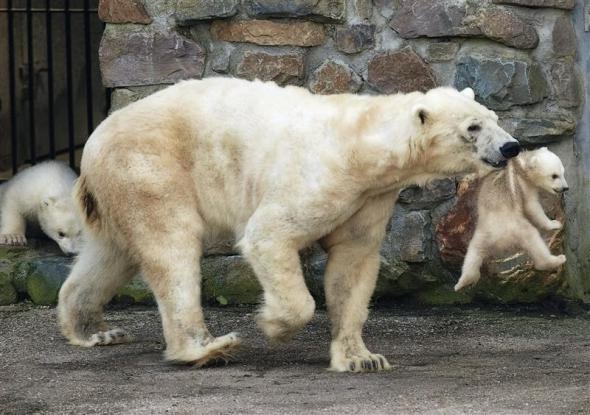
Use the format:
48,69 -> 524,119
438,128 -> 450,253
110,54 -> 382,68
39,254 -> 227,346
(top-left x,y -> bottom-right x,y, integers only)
174,0 -> 239,25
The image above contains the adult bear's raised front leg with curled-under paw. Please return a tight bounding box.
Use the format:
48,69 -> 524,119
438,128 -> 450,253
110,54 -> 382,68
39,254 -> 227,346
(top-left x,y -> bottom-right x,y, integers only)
239,212 -> 315,342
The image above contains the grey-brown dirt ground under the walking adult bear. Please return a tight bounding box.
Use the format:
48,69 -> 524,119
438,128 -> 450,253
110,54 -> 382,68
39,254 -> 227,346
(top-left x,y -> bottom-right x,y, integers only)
0,305 -> 590,415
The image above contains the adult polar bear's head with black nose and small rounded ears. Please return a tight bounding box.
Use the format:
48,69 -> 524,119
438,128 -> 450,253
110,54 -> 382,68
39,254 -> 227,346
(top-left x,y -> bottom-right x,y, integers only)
412,87 -> 520,174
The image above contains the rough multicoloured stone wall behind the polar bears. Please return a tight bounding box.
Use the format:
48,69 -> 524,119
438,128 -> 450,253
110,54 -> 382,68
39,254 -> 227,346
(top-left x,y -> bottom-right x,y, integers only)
23,0 -> 588,304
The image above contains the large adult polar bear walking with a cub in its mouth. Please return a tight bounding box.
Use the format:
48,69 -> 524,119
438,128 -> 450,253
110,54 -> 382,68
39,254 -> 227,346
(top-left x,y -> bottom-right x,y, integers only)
58,78 -> 519,372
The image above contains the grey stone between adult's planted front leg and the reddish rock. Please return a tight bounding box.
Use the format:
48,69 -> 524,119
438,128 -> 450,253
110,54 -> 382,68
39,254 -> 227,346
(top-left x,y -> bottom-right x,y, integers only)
383,209 -> 431,262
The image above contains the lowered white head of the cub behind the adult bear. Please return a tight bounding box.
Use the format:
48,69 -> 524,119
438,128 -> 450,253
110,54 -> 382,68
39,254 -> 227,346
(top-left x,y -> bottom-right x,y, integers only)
39,197 -> 83,255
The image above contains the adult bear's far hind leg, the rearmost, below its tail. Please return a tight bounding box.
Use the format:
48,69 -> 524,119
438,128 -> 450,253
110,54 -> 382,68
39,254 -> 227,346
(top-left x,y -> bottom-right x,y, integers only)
57,239 -> 137,347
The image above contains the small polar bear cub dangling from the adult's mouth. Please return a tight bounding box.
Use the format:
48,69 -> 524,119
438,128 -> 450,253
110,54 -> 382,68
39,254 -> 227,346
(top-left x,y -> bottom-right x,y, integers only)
455,147 -> 568,291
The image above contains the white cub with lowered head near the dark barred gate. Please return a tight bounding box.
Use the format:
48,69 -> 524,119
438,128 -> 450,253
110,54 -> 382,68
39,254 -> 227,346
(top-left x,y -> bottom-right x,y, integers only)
0,161 -> 82,254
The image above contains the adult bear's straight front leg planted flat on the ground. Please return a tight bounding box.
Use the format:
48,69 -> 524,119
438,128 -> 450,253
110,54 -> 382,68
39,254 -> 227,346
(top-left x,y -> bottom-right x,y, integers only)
322,192 -> 397,372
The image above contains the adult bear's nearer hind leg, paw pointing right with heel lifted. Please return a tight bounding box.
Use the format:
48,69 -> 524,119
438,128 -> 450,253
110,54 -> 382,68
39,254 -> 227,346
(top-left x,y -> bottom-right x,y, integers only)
141,228 -> 240,367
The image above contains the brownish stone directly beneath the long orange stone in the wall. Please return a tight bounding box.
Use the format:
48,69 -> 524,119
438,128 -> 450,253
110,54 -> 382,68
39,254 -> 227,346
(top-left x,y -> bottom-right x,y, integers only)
236,51 -> 305,85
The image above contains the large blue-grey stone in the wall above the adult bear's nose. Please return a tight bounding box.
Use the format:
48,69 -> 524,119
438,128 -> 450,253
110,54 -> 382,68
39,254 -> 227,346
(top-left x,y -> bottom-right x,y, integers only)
455,55 -> 549,110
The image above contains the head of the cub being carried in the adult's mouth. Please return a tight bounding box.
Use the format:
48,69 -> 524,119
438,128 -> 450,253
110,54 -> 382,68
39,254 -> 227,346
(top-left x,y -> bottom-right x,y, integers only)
519,147 -> 569,193
